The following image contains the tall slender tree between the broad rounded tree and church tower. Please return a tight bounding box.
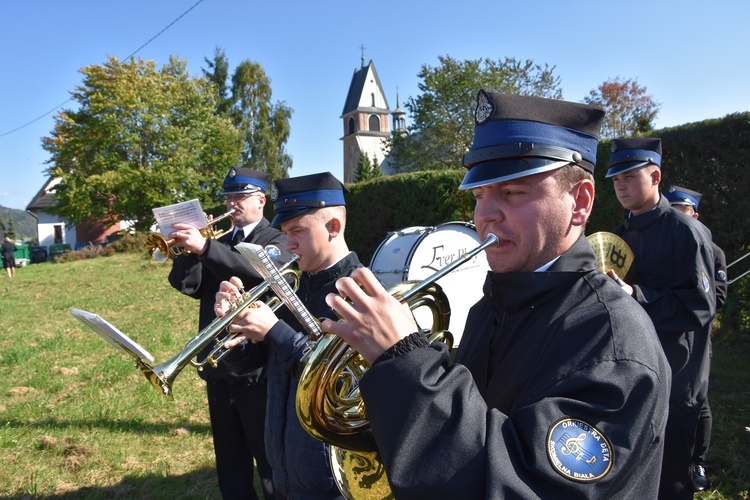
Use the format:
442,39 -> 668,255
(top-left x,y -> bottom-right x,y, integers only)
203,48 -> 293,179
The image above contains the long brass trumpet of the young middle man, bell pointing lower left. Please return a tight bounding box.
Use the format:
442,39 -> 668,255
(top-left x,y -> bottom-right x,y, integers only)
136,255 -> 299,400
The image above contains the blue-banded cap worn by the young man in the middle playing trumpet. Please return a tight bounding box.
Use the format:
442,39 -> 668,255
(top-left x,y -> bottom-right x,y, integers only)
271,172 -> 349,227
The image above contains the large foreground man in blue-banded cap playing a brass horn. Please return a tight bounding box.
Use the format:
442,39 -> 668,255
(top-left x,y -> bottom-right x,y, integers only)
323,90 -> 670,499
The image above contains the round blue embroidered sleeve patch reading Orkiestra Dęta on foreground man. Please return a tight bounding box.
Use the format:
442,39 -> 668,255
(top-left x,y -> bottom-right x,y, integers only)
547,418 -> 614,482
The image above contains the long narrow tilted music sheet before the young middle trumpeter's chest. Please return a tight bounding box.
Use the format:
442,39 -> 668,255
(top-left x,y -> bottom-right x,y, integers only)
234,242 -> 323,338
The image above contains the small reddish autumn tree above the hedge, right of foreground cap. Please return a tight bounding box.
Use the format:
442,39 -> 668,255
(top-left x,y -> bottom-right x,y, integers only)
583,76 -> 661,139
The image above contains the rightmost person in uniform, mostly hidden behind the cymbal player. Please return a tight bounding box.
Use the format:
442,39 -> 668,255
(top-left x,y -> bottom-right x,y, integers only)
664,186 -> 729,492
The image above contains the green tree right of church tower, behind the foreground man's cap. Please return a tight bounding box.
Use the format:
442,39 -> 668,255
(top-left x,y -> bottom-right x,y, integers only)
385,56 -> 562,171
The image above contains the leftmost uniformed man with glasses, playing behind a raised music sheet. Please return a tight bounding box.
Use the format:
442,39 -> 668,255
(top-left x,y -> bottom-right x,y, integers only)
169,168 -> 291,499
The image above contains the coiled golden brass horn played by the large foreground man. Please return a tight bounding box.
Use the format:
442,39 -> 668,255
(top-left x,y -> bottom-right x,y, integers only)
296,234 -> 498,498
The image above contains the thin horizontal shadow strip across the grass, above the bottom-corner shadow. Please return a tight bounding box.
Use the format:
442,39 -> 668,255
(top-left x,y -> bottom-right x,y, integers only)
3,419 -> 211,434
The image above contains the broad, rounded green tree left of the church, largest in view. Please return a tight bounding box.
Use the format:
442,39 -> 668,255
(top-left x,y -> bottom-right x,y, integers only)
42,57 -> 241,230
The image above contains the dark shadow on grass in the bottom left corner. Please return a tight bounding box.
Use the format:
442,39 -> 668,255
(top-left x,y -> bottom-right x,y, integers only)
4,469 -> 221,500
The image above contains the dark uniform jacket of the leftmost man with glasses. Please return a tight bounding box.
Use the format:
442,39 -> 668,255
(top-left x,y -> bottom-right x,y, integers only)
169,218 -> 291,384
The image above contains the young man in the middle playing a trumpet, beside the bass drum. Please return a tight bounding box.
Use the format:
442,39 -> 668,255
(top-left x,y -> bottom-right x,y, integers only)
216,172 -> 362,500
